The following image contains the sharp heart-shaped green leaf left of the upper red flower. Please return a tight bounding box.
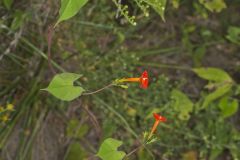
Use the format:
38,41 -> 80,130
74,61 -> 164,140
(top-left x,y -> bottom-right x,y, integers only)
43,73 -> 84,101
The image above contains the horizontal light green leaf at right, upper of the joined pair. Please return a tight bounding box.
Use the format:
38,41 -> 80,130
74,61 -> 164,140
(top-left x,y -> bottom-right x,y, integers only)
193,67 -> 232,82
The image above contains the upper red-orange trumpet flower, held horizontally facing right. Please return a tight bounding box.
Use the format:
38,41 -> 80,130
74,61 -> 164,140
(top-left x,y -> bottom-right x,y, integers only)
119,71 -> 149,89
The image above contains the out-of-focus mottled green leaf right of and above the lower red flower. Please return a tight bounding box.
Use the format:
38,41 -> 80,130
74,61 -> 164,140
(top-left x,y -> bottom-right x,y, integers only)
171,89 -> 193,120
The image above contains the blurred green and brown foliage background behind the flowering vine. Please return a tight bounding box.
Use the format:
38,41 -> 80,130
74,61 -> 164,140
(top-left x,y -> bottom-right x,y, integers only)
0,0 -> 240,160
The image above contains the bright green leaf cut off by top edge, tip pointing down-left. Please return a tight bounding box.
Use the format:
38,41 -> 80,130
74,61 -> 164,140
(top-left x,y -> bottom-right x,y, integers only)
55,0 -> 88,26
